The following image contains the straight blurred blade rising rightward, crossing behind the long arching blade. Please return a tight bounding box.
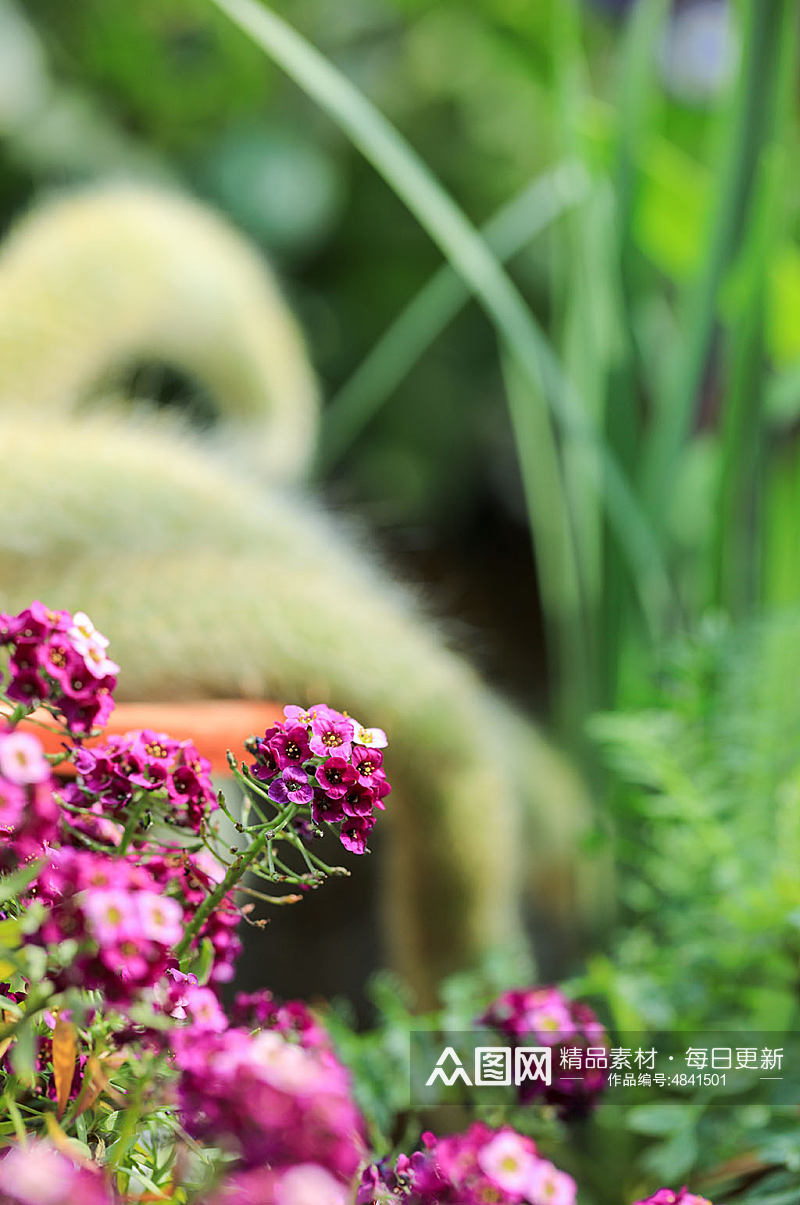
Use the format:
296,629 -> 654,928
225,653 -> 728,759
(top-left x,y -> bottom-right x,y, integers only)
318,161 -> 589,471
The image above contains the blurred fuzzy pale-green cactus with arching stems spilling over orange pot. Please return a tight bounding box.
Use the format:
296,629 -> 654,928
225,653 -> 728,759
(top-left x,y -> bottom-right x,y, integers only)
0,190 -> 602,998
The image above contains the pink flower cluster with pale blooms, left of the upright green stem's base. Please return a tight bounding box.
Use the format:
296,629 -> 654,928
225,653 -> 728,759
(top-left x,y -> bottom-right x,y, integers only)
31,846 -> 184,1005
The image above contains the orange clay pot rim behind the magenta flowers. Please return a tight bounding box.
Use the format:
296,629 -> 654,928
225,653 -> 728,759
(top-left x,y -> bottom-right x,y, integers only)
19,699 -> 283,775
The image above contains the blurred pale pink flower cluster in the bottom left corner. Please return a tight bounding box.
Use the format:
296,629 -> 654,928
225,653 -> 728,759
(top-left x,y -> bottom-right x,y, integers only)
0,1139 -> 116,1205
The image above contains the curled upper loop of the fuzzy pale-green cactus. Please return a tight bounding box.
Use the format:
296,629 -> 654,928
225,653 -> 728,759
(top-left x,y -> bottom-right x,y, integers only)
0,187 -> 317,481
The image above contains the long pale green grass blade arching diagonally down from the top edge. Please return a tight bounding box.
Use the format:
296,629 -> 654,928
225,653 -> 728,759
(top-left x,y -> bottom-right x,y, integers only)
211,0 -> 672,630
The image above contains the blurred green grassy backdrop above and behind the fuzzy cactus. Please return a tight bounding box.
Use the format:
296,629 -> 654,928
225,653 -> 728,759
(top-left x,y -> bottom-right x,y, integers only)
0,0 -> 800,736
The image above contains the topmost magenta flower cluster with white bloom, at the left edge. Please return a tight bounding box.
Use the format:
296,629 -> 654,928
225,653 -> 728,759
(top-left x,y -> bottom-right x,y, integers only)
0,603 -> 119,735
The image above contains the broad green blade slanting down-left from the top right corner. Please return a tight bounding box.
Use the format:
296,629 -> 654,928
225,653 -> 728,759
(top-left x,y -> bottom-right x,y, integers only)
645,0 -> 794,522
